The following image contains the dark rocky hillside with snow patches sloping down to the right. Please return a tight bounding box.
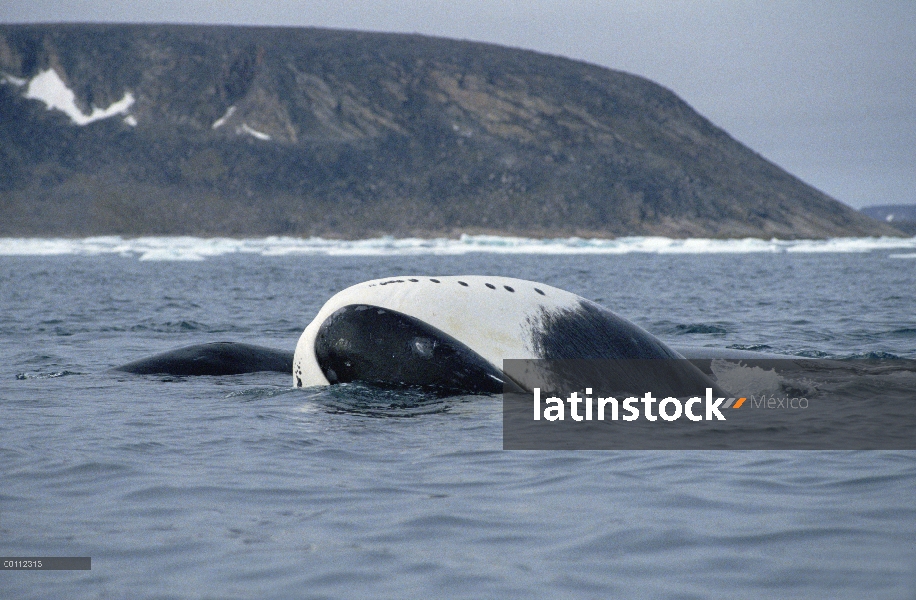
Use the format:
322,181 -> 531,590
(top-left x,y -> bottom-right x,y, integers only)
0,25 -> 897,238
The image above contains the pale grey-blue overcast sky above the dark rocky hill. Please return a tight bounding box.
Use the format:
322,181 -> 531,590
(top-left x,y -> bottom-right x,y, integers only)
0,0 -> 916,208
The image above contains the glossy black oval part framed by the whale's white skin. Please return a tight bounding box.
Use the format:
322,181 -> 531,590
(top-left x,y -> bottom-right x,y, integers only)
315,304 -> 505,394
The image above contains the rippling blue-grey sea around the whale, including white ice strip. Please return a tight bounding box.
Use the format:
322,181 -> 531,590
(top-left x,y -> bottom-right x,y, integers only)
0,238 -> 916,600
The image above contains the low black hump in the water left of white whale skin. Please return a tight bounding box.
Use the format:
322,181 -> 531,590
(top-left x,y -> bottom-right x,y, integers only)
115,342 -> 293,376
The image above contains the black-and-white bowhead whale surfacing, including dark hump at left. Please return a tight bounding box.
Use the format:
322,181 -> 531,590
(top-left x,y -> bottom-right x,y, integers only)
118,275 -> 720,393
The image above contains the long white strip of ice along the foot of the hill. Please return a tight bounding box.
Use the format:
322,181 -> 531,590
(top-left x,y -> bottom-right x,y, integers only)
0,235 -> 916,261
